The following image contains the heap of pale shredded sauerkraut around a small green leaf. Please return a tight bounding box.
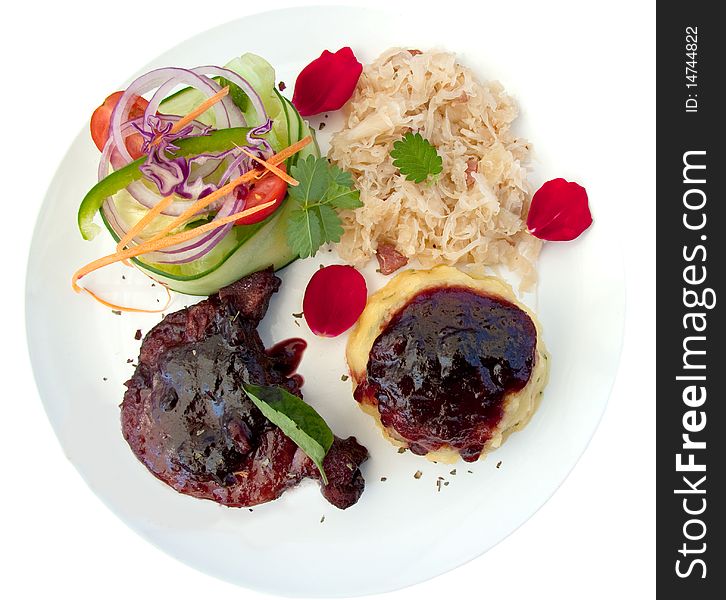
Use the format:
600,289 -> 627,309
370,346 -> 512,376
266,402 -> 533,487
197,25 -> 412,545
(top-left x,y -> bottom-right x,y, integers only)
328,48 -> 541,289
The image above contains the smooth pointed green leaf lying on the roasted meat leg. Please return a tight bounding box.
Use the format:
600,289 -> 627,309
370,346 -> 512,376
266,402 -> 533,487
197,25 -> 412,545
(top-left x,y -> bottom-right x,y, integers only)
242,383 -> 333,485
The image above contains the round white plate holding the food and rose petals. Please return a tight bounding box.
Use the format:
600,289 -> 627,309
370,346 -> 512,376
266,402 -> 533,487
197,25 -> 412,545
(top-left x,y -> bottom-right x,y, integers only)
27,7 -> 624,596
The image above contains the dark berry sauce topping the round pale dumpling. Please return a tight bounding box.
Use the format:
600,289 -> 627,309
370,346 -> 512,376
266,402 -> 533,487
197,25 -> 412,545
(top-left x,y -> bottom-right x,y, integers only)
355,287 -> 537,462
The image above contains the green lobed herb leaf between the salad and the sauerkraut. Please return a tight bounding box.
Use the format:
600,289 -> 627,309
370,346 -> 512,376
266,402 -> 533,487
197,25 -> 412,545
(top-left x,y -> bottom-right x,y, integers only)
287,156 -> 363,258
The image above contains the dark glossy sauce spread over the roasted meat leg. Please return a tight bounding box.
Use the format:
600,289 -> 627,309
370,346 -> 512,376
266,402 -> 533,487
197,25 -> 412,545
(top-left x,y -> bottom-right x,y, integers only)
152,334 -> 307,485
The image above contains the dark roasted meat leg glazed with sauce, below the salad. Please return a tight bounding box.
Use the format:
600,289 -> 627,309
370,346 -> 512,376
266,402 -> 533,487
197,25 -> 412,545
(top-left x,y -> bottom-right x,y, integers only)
121,270 -> 368,508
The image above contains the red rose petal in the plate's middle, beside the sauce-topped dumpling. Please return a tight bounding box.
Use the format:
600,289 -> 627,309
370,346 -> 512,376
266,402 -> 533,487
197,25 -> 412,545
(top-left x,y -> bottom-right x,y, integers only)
303,265 -> 368,337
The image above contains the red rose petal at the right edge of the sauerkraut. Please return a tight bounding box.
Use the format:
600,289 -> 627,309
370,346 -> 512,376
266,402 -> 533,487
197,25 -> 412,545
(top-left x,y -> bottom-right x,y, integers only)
527,178 -> 592,242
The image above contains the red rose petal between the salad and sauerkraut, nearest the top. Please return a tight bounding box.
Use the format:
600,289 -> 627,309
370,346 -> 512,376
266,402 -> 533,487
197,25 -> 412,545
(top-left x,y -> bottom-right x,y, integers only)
292,46 -> 363,117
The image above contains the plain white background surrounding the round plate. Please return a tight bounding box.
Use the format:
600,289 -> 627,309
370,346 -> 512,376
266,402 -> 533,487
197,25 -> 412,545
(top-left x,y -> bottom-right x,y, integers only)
0,0 -> 655,600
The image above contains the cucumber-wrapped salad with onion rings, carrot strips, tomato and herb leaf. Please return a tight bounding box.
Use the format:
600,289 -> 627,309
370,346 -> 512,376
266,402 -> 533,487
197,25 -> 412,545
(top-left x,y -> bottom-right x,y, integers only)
73,53 -> 359,302
